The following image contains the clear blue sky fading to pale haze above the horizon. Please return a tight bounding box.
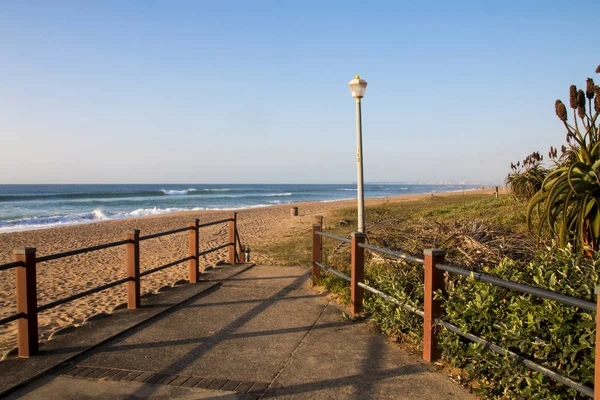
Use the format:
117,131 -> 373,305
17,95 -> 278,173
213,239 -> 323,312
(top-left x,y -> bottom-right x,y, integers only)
0,0 -> 600,184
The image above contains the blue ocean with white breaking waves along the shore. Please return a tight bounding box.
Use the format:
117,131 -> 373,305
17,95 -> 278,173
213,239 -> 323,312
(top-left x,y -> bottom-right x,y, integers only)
0,184 -> 479,233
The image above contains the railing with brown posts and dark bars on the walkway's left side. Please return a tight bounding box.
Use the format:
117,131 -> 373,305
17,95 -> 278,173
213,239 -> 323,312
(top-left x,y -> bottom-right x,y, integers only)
0,213 -> 242,357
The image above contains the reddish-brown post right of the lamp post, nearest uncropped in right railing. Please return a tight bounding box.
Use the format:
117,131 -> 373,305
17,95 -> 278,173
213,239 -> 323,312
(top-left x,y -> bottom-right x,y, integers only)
423,249 -> 446,362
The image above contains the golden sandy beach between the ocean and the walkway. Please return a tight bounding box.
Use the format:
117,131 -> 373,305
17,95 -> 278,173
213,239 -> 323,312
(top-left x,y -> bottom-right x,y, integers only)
0,189 -> 494,354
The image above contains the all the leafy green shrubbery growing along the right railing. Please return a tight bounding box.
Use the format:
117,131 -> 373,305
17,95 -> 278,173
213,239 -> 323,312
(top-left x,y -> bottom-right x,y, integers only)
322,246 -> 600,399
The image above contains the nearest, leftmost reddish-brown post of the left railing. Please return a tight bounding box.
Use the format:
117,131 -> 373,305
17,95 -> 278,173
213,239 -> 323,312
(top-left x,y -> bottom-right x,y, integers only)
13,247 -> 39,357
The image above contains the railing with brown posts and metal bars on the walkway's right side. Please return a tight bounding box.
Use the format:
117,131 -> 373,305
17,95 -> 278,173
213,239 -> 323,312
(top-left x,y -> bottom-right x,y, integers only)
312,216 -> 600,398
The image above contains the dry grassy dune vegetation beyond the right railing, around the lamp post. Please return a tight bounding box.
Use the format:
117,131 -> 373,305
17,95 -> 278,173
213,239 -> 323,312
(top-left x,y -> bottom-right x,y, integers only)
260,194 -> 535,267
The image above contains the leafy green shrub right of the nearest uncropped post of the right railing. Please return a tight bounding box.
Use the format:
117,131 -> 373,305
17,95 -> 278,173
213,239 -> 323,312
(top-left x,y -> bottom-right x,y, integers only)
441,246 -> 600,399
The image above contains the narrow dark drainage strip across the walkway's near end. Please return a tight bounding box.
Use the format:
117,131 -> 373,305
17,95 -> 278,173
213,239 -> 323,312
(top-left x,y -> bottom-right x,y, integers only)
60,366 -> 269,395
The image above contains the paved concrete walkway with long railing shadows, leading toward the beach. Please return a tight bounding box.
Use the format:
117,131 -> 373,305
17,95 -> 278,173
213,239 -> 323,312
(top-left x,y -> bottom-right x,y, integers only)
3,266 -> 476,400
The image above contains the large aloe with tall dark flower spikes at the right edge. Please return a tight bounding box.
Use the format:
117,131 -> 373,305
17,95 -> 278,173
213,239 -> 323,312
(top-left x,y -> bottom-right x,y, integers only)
527,66 -> 600,253
